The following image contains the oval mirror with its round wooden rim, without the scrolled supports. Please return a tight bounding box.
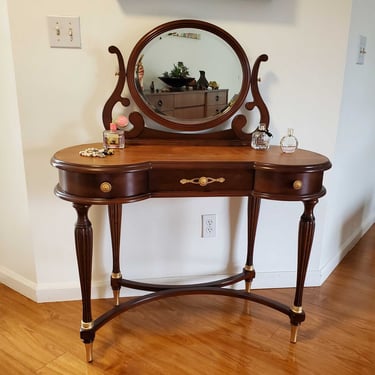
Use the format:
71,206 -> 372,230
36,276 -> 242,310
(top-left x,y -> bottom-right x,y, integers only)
127,20 -> 251,131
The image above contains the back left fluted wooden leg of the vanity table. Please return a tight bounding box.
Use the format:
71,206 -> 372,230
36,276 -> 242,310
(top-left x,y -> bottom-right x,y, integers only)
108,204 -> 122,306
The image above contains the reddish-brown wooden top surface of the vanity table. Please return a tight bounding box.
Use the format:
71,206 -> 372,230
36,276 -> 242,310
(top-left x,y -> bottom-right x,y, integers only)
51,143 -> 331,170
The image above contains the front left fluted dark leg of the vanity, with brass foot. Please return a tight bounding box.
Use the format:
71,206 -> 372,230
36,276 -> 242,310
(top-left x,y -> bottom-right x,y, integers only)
73,203 -> 95,362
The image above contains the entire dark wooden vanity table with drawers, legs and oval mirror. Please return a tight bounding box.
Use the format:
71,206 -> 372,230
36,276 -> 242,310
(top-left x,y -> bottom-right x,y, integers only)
51,20 -> 331,362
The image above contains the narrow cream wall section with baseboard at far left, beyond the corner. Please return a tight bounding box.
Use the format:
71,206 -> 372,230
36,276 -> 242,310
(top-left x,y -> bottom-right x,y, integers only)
0,0 -> 36,300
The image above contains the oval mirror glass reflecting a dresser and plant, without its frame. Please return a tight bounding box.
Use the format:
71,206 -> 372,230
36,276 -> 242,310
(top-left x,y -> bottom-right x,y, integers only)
134,28 -> 243,119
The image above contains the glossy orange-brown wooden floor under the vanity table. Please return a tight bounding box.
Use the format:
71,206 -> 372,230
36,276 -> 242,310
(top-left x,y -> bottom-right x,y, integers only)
0,225 -> 375,375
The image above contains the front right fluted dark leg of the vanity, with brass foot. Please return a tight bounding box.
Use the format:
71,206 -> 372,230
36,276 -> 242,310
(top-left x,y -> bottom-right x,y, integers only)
290,199 -> 318,343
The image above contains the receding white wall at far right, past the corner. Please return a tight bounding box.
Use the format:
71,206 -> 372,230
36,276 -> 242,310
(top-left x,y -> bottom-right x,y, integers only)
321,0 -> 375,278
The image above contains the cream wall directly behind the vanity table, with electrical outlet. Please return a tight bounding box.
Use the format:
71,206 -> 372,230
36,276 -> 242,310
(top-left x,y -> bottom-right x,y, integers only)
0,0 -> 374,301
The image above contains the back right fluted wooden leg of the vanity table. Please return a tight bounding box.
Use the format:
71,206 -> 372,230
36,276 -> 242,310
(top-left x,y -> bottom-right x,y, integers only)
244,196 -> 260,293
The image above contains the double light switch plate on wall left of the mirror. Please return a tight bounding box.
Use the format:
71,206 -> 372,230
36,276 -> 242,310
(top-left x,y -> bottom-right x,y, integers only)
47,16 -> 81,48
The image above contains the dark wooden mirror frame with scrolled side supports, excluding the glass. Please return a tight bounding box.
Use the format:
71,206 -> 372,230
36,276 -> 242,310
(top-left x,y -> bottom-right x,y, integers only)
102,19 -> 269,145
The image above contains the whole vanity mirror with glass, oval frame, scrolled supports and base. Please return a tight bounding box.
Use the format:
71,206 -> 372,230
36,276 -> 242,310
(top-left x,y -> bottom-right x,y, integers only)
103,20 -> 269,145
